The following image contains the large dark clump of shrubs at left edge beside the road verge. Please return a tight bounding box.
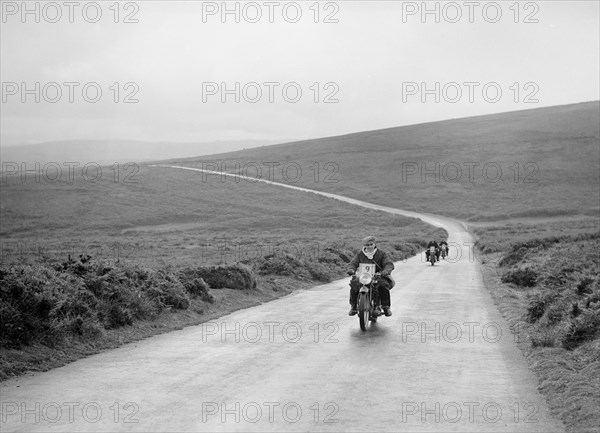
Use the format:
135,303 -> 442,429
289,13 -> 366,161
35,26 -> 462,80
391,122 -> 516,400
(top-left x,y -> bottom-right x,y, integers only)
0,256 -> 202,348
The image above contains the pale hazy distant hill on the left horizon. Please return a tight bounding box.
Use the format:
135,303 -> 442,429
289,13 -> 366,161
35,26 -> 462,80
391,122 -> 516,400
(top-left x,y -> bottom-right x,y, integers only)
0,140 -> 282,165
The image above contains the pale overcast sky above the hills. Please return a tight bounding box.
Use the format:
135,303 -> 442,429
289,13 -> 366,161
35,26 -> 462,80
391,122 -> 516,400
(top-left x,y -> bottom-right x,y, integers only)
0,1 -> 600,146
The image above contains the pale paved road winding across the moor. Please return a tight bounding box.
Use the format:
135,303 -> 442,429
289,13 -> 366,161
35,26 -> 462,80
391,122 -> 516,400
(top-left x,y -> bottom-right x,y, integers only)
0,165 -> 564,432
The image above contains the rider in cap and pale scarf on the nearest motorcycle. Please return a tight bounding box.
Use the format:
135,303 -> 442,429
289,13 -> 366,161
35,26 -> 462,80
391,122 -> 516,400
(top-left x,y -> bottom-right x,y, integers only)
346,236 -> 394,317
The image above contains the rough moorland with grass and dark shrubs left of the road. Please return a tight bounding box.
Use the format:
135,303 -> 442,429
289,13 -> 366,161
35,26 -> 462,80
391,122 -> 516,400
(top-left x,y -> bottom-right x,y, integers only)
0,167 -> 445,379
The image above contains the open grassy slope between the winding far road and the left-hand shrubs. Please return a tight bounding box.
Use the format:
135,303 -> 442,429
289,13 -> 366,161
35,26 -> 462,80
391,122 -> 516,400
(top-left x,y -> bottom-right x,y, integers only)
0,166 -> 440,265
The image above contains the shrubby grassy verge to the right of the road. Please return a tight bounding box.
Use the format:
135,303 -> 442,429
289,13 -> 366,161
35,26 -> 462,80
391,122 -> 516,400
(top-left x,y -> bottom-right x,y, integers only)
475,218 -> 600,432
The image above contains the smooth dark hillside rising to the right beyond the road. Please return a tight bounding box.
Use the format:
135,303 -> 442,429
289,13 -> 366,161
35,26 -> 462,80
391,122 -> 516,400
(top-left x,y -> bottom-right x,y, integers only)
173,102 -> 600,220
